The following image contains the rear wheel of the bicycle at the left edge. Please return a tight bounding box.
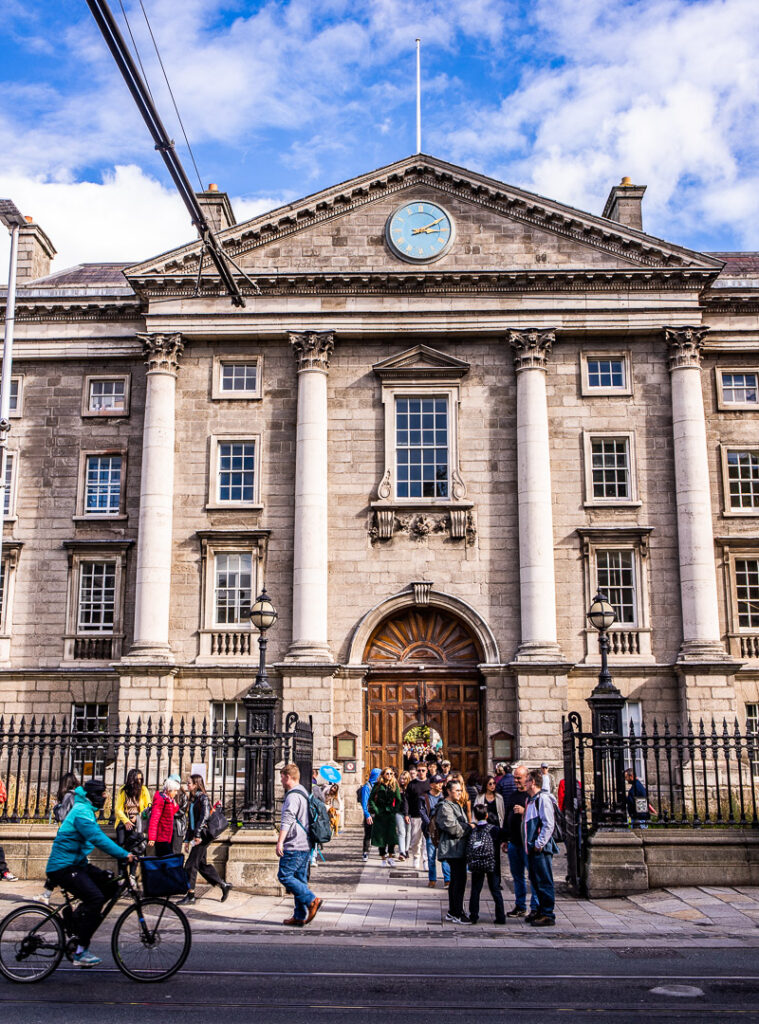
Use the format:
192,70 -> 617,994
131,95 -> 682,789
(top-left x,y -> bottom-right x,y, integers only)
0,905 -> 64,982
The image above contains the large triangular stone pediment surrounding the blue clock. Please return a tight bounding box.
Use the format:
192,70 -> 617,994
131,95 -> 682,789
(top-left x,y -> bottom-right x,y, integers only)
126,155 -> 722,290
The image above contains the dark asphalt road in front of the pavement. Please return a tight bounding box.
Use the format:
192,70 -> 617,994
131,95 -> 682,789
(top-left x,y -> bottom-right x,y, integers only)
0,933 -> 759,1024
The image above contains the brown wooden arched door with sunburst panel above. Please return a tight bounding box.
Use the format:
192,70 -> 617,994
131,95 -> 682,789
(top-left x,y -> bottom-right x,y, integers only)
364,607 -> 483,774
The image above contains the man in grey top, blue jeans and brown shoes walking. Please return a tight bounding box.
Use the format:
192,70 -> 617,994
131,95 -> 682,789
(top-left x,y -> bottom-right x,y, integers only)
277,764 -> 322,928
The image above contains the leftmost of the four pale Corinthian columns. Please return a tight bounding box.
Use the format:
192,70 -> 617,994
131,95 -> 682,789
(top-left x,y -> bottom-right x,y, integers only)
129,334 -> 183,662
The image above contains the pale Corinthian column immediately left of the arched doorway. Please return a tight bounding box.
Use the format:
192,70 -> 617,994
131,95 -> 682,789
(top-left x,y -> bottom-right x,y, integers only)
287,331 -> 335,662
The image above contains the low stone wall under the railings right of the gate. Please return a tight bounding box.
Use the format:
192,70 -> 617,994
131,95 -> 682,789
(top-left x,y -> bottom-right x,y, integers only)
586,828 -> 759,899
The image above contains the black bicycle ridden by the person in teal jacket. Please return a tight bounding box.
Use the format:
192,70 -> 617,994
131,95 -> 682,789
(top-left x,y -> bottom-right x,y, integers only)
0,862 -> 192,983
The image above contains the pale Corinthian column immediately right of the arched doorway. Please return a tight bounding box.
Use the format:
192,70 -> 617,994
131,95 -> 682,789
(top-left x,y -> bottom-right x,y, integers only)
508,331 -> 559,662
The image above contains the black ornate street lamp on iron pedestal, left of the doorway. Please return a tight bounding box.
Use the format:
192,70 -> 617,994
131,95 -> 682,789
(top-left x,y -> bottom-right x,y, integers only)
242,587 -> 278,828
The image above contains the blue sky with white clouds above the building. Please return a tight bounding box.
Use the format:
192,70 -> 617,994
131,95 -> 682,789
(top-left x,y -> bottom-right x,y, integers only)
0,0 -> 759,280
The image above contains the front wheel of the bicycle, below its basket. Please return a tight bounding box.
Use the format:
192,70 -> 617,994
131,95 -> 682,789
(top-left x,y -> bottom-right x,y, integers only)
111,899 -> 193,981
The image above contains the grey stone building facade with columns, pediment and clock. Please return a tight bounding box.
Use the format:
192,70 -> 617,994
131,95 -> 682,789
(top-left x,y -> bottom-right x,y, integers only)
0,156 -> 759,774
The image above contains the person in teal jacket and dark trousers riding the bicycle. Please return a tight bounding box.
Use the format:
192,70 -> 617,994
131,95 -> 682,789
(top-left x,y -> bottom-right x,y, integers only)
45,779 -> 134,967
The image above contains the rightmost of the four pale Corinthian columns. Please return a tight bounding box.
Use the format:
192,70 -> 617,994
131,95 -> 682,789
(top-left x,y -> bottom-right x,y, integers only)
664,327 -> 727,660
